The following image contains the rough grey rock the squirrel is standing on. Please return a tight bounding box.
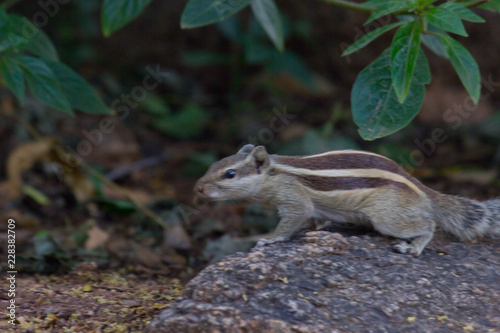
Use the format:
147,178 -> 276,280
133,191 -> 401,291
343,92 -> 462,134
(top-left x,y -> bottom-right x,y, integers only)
149,226 -> 500,333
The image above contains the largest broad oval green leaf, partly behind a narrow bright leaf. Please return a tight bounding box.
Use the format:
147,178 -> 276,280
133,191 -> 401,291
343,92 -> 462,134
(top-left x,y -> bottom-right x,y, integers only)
351,49 -> 430,140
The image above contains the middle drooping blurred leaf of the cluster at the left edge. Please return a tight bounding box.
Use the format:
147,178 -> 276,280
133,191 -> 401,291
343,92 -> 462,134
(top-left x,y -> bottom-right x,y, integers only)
18,56 -> 73,115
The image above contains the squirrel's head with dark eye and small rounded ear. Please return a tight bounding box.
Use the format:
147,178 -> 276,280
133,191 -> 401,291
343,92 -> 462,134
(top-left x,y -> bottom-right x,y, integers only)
194,144 -> 270,200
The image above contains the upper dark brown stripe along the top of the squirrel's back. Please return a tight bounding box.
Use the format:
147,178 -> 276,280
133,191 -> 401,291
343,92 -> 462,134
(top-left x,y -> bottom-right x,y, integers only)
272,153 -> 427,192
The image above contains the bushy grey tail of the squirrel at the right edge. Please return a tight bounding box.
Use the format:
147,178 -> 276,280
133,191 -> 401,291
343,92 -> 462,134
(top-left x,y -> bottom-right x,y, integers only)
434,194 -> 500,240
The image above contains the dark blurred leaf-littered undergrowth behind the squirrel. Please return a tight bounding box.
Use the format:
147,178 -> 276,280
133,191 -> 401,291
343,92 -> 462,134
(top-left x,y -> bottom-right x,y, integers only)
0,0 -> 500,275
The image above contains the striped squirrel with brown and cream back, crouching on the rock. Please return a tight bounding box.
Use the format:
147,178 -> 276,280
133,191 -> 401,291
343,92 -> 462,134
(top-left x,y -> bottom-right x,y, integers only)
195,145 -> 500,256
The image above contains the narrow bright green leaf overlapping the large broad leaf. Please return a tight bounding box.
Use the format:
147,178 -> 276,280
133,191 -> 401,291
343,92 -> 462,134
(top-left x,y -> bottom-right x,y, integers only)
391,20 -> 422,103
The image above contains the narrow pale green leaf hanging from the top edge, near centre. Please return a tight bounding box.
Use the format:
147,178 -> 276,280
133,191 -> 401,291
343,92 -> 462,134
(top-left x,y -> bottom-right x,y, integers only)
250,0 -> 285,51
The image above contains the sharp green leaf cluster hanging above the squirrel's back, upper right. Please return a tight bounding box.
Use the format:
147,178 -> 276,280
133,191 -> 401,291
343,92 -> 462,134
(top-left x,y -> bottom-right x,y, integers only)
342,0 -> 484,140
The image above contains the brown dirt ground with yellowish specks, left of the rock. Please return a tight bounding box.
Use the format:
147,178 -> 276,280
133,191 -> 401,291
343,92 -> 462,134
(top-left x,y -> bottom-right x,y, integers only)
0,263 -> 183,332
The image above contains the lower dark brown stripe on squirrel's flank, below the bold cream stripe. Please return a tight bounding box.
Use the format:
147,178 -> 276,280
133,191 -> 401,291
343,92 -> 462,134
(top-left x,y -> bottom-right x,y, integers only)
295,175 -> 414,192
